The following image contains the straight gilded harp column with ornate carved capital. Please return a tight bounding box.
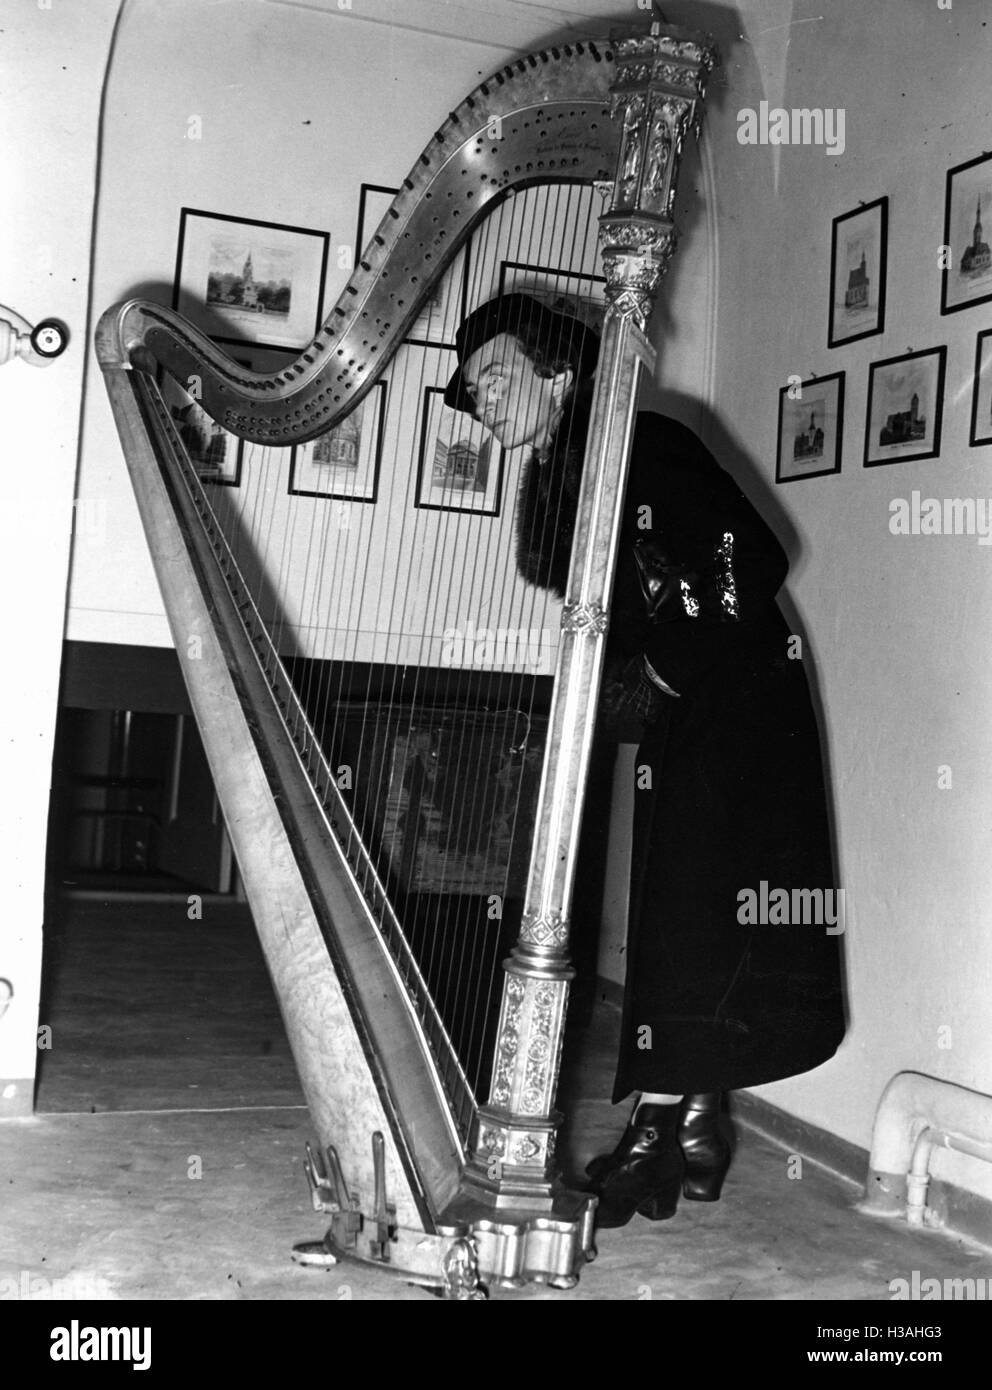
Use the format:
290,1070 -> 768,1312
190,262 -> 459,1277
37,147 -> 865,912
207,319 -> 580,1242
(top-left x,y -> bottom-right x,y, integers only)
465,22 -> 714,1211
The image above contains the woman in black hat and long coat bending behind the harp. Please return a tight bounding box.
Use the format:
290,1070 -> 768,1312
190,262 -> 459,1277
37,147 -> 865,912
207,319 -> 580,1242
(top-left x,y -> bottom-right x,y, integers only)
445,293 -> 845,1226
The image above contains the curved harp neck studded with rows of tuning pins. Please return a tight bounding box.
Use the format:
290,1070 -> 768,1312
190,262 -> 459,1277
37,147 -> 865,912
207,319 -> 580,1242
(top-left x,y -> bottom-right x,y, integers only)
97,42 -> 630,446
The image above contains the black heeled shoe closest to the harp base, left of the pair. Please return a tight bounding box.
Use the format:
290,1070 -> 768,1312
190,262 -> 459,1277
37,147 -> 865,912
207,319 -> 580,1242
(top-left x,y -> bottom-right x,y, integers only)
586,1104 -> 684,1227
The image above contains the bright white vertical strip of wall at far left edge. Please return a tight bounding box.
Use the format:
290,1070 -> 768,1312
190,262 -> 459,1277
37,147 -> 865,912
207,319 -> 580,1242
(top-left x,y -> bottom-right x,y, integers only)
0,0 -> 117,1116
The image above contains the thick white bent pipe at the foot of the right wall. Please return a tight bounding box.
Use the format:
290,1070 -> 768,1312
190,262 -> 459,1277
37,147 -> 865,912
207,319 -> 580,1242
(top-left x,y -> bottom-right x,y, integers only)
861,1072 -> 992,1226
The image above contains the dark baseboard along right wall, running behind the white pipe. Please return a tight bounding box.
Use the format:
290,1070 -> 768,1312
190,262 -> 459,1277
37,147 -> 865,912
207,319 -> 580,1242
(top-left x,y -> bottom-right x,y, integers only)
729,1091 -> 992,1248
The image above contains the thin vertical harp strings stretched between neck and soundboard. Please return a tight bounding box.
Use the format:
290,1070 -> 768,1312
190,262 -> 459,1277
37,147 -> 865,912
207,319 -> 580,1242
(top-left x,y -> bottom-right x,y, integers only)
175,183 -> 599,1125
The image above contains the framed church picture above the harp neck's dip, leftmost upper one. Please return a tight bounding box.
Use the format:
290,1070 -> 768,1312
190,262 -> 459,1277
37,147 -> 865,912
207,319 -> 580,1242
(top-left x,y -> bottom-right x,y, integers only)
172,207 -> 331,349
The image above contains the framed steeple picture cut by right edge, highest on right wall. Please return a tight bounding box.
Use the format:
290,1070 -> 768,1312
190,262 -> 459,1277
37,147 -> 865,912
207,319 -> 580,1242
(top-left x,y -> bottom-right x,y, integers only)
941,154 -> 992,314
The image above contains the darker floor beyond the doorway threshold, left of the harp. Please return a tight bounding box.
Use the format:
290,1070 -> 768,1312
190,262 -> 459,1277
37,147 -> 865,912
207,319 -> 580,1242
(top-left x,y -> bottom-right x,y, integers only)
36,898 -> 303,1113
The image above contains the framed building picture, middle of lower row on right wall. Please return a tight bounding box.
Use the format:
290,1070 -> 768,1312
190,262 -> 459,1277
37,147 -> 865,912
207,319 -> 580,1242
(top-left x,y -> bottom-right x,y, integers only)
864,348 -> 948,468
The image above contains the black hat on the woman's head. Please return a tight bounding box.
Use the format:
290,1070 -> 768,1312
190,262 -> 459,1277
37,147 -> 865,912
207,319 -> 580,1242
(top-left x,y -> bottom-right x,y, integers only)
445,293 -> 599,416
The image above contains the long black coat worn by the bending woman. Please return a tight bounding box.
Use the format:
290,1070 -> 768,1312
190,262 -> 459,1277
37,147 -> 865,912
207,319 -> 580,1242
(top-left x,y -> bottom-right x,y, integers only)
518,405 -> 845,1101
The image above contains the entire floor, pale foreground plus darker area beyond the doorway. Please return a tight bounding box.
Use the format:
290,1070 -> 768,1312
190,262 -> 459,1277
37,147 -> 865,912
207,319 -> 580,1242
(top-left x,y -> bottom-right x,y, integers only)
0,901 -> 992,1301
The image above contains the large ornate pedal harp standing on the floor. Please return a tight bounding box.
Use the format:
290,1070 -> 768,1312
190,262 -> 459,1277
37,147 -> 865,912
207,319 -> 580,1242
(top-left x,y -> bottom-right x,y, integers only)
97,21 -> 713,1295
